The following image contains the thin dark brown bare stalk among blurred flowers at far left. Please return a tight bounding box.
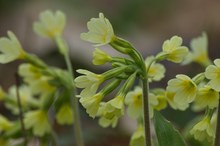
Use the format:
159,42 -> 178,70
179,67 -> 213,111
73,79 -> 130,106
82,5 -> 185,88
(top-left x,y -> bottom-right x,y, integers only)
15,73 -> 27,146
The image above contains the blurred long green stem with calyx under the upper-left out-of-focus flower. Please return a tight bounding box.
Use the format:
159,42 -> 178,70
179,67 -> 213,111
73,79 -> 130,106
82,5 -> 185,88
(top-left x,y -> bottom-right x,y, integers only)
56,37 -> 84,146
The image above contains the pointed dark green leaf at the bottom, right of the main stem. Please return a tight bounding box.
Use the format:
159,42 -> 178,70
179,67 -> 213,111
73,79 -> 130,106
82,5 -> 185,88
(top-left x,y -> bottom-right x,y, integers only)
154,111 -> 186,146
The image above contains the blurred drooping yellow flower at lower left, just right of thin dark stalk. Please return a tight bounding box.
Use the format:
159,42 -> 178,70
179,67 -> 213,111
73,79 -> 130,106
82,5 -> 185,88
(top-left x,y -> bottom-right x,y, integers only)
24,110 -> 50,137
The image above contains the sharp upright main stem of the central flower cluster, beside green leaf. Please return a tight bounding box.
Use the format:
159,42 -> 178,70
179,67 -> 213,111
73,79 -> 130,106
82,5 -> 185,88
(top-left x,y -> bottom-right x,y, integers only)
142,78 -> 151,146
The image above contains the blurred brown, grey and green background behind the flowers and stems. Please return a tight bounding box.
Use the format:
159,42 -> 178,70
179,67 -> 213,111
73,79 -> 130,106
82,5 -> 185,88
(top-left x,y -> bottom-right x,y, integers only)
0,0 -> 220,146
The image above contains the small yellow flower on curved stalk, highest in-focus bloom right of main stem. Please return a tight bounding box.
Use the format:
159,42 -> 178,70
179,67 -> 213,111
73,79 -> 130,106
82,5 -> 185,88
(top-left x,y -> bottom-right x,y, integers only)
163,36 -> 188,63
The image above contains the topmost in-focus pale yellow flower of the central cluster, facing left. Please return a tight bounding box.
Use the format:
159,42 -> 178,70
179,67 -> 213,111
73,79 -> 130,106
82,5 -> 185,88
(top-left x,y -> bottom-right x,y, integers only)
81,13 -> 114,46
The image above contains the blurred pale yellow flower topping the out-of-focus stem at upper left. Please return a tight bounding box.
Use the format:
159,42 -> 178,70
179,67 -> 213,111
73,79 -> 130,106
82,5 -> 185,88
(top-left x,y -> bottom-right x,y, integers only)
34,10 -> 66,39
